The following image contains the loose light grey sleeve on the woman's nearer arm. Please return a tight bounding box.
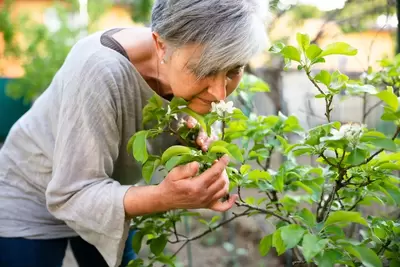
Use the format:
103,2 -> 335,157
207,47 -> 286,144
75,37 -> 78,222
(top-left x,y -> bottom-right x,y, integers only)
46,62 -> 130,266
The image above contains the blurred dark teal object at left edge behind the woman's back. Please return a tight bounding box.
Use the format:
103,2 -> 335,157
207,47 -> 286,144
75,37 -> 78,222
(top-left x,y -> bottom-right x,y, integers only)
0,77 -> 30,142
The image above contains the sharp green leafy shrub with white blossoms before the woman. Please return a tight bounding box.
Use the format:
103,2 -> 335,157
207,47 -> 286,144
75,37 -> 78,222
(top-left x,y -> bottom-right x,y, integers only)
128,34 -> 400,267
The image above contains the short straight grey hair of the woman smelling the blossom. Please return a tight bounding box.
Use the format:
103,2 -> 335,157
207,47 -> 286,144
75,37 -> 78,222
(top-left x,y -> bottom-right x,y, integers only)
151,0 -> 268,77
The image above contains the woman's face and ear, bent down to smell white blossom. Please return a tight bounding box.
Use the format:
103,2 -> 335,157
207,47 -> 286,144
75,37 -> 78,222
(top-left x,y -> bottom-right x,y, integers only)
163,45 -> 244,114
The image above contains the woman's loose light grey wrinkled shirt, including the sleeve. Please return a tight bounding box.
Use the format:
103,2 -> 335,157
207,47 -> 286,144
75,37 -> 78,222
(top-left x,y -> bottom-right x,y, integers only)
0,32 -> 176,266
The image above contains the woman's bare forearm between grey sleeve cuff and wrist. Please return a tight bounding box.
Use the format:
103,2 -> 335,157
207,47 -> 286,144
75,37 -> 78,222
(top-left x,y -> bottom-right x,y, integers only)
124,185 -> 170,217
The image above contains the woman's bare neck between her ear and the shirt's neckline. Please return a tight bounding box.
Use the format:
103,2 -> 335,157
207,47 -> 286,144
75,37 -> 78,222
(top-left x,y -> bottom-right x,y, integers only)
113,28 -> 172,99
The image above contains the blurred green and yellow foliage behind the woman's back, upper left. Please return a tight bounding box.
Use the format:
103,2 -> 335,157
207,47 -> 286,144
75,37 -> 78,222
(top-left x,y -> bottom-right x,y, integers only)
0,0 -> 111,103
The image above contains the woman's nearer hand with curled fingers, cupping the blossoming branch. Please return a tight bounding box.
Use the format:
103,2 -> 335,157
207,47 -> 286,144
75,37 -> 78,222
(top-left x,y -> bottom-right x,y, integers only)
158,155 -> 238,212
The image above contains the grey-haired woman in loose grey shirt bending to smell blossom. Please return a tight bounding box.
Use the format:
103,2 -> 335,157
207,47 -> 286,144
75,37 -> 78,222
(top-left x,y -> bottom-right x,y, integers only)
0,0 -> 266,267
